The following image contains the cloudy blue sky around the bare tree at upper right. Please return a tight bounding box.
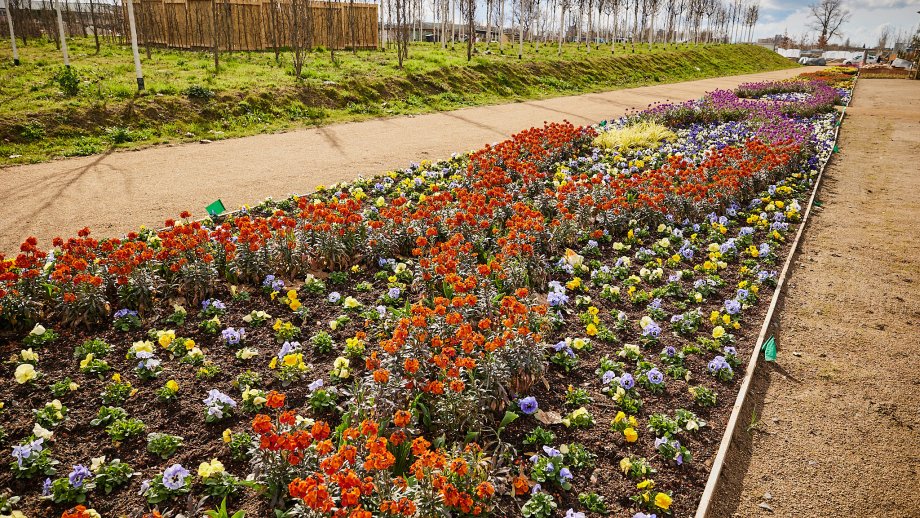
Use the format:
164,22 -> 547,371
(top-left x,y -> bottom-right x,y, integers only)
754,0 -> 920,46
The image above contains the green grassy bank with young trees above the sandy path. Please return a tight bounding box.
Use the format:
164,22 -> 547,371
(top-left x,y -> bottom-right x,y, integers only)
0,38 -> 795,166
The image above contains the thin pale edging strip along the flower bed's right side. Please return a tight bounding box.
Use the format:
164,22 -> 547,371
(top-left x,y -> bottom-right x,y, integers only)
694,73 -> 859,518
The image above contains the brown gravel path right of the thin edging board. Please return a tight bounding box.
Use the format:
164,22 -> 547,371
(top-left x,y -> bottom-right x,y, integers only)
713,79 -> 920,517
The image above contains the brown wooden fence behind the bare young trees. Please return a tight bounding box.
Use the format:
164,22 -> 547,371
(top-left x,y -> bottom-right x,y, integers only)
125,0 -> 378,51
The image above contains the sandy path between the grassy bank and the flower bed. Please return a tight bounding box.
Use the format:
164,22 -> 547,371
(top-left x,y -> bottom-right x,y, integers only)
0,69 -> 802,252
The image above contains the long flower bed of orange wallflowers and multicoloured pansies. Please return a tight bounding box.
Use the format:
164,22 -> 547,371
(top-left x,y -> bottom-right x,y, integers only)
0,72 -> 839,516
